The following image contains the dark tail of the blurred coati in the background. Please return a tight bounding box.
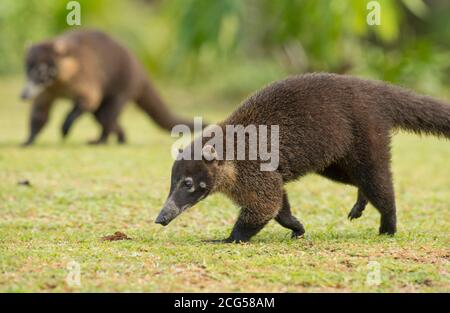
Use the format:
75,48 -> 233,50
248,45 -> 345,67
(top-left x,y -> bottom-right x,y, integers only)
136,82 -> 194,131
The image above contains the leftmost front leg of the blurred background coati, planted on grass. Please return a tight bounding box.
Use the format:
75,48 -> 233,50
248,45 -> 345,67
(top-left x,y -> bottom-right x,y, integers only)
22,92 -> 54,146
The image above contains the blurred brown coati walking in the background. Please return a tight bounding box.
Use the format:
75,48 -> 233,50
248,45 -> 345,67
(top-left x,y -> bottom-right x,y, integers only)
22,30 -> 197,145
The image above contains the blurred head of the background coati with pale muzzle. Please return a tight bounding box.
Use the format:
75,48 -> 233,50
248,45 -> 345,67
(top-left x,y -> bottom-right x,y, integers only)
21,40 -> 73,100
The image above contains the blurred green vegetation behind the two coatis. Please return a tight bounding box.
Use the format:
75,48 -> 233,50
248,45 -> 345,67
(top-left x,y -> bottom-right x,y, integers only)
0,0 -> 450,99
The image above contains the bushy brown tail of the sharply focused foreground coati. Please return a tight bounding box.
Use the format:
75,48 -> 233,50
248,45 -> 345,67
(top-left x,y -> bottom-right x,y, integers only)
385,87 -> 450,138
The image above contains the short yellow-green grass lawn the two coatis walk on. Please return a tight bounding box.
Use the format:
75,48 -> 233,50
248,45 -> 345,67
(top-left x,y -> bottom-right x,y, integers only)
0,76 -> 450,292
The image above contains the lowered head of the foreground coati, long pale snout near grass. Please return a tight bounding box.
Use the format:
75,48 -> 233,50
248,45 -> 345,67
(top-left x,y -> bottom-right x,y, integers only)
155,145 -> 221,226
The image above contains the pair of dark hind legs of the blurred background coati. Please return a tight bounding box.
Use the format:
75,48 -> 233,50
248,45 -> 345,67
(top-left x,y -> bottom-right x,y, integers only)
89,98 -> 125,145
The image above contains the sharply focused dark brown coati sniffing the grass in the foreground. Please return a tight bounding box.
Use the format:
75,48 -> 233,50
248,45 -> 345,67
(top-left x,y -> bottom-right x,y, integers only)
155,73 -> 450,242
